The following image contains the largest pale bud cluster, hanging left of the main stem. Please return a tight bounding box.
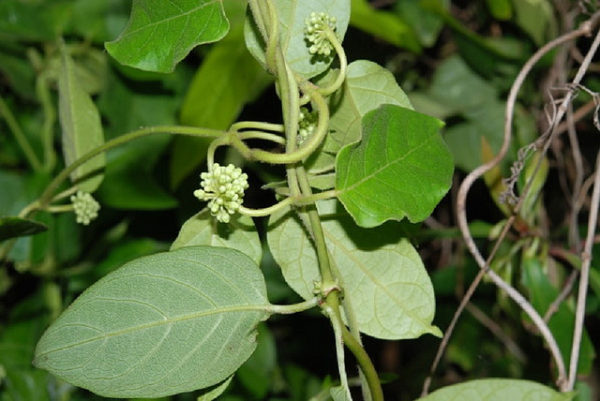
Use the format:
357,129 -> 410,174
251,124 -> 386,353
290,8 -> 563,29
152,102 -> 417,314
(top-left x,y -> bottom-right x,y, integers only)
194,163 -> 248,223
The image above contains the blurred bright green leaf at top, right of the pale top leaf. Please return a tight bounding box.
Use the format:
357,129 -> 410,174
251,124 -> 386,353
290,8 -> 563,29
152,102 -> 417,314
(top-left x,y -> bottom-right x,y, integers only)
350,0 -> 421,53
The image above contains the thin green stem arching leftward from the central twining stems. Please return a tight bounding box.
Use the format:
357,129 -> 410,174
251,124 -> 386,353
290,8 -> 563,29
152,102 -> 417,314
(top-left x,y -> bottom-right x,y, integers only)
39,125 -> 226,209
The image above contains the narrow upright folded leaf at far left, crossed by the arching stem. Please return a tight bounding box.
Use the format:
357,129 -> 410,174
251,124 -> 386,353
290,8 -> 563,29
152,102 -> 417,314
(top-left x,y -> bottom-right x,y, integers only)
58,45 -> 106,192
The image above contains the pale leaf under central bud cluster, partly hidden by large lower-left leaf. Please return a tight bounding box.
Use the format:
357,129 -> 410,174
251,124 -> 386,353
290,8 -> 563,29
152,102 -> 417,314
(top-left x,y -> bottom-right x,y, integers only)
171,208 -> 262,264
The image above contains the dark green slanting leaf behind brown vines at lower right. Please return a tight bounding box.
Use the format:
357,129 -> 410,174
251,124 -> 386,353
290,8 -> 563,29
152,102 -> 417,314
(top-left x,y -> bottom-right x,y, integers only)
521,257 -> 596,375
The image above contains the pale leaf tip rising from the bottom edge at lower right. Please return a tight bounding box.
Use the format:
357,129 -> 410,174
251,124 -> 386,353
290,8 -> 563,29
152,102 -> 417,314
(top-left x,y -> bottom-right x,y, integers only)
419,379 -> 575,401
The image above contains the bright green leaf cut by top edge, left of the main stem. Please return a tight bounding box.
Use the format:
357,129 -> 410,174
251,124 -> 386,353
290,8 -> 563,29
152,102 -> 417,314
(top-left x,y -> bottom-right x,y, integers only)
105,0 -> 229,72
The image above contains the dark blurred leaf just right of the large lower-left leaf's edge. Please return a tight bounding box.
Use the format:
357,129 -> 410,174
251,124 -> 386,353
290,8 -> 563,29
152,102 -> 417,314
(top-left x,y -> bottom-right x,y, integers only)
236,324 -> 277,400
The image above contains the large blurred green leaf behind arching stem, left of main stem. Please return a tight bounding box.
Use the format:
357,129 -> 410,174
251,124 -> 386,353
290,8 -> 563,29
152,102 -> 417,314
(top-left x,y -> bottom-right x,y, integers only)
171,26 -> 273,187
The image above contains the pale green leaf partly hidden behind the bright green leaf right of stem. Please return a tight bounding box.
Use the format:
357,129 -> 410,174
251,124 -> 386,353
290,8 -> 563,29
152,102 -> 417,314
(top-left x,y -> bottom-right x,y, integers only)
308,60 -> 413,171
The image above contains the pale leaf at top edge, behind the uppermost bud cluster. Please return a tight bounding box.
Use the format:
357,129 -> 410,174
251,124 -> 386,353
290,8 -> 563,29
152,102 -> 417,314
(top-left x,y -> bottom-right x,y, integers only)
244,0 -> 350,78
